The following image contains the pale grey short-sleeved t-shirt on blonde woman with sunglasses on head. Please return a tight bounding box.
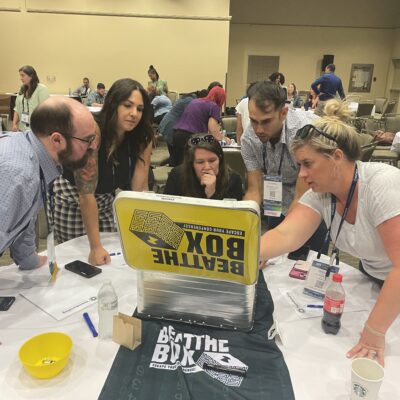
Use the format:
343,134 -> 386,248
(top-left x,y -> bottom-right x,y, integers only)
299,161 -> 400,280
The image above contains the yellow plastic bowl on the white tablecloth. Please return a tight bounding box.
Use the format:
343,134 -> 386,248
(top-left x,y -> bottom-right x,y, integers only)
19,332 -> 72,379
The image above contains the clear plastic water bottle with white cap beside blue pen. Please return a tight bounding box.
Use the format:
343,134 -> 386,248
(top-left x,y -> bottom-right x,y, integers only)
97,280 -> 118,339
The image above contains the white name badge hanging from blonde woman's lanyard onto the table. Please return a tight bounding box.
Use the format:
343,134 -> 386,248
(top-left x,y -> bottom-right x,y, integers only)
303,258 -> 339,300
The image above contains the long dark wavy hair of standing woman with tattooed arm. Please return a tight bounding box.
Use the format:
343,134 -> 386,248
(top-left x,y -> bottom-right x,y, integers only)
95,78 -> 153,162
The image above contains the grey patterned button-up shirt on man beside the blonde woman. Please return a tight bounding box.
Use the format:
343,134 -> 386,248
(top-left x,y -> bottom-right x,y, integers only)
241,109 -> 318,215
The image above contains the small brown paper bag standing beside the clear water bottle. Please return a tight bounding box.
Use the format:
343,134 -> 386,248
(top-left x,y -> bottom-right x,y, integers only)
113,313 -> 142,350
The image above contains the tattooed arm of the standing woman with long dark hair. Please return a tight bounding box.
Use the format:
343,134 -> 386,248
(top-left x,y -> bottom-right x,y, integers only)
75,128 -> 111,265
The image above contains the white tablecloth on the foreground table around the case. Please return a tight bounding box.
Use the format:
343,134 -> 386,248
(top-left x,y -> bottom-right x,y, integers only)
0,234 -> 400,400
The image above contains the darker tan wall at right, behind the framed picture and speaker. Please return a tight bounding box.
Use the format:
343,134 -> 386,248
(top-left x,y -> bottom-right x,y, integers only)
227,23 -> 395,105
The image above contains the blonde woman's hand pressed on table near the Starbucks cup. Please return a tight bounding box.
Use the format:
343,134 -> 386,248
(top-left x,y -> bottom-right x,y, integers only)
347,328 -> 385,367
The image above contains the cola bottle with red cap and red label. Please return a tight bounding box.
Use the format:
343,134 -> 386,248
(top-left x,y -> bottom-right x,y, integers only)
321,274 -> 345,335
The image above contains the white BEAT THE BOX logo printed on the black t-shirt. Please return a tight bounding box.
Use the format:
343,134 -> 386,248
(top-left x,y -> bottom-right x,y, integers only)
150,325 -> 248,386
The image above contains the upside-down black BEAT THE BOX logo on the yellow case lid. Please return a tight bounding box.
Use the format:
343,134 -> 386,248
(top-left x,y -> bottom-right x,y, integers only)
129,209 -> 245,276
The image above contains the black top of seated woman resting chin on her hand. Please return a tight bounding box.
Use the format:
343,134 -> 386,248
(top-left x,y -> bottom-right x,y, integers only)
164,164 -> 243,200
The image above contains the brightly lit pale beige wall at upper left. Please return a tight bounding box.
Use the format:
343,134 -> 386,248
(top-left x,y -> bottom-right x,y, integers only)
0,0 -> 230,93
